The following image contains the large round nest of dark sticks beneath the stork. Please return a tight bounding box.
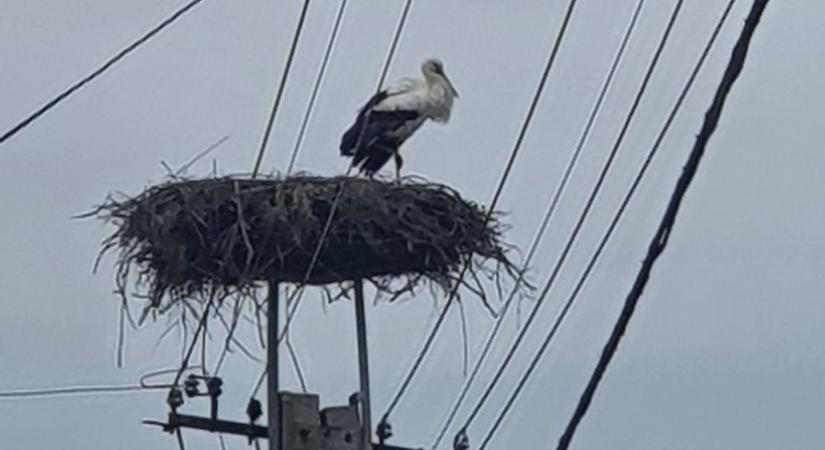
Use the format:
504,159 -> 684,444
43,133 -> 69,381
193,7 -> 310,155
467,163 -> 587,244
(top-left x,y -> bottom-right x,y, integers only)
95,176 -> 512,312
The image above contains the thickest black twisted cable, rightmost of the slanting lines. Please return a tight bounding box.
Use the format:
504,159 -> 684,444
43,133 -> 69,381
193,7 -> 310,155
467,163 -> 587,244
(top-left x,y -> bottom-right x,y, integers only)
557,0 -> 768,450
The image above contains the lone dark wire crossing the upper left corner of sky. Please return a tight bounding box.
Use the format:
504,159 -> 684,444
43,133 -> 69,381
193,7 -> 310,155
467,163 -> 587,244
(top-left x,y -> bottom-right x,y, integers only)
0,0 -> 203,144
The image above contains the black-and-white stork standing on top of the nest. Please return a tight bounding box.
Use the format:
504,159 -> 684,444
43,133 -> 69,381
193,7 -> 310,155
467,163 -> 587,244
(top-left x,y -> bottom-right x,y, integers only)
340,59 -> 458,178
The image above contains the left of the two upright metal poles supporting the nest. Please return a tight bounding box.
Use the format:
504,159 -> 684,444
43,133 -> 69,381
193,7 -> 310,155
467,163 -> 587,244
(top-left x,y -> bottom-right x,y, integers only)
266,280 -> 281,450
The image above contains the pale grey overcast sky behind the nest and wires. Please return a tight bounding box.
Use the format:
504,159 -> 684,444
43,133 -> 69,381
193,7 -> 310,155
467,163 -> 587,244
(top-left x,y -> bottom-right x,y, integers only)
0,0 -> 825,450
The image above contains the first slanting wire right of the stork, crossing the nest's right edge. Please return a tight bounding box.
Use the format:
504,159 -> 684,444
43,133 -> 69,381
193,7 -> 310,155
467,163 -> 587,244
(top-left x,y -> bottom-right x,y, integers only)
381,0 -> 577,430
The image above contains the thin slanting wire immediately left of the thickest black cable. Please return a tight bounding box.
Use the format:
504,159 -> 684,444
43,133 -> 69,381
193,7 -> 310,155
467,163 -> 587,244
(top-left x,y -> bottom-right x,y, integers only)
474,0 -> 735,442
